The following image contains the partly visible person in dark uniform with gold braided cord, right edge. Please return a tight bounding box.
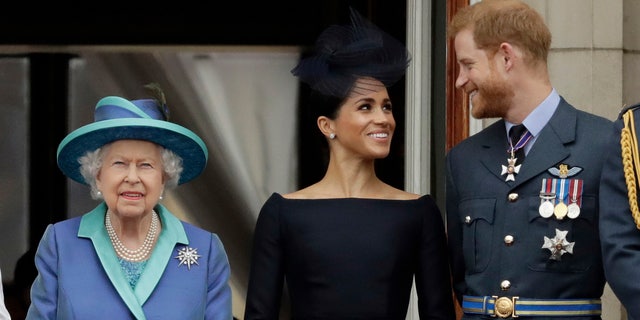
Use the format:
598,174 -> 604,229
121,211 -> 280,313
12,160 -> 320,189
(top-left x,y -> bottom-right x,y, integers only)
600,104 -> 640,319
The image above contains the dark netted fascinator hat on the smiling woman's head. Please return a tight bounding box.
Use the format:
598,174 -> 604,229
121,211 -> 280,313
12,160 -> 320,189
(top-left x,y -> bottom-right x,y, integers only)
291,8 -> 411,98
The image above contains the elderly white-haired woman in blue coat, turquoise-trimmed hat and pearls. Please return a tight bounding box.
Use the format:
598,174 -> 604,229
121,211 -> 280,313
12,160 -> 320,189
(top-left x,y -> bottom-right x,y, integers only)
27,87 -> 232,320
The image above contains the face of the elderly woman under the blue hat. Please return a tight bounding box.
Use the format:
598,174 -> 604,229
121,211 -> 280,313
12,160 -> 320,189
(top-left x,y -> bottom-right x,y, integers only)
96,140 -> 164,217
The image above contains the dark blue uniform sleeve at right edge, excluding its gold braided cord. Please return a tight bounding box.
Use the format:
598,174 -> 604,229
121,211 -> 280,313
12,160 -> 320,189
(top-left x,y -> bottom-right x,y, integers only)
600,105 -> 640,319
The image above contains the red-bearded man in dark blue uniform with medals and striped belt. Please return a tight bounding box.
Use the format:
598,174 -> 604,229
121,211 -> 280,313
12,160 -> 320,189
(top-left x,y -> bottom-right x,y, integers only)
446,0 -> 612,319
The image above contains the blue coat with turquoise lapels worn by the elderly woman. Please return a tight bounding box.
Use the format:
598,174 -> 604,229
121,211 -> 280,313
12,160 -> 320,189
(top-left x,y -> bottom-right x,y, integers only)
27,203 -> 232,320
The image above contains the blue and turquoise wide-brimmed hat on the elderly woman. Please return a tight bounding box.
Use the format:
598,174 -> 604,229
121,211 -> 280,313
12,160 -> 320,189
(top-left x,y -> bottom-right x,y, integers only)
58,96 -> 209,184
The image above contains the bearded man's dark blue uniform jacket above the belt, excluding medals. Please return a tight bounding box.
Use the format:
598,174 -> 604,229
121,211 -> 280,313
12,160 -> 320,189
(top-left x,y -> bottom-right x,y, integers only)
446,99 -> 612,310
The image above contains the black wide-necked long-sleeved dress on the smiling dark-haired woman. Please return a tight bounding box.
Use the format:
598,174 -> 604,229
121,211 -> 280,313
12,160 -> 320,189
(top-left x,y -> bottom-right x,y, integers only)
245,193 -> 455,320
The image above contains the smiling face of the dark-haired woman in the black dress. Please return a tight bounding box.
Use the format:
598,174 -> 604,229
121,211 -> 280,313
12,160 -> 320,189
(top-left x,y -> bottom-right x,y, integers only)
333,78 -> 396,159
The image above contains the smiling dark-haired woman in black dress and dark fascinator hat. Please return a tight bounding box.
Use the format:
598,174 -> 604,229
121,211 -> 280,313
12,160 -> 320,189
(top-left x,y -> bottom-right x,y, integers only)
245,10 -> 455,320
